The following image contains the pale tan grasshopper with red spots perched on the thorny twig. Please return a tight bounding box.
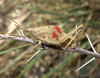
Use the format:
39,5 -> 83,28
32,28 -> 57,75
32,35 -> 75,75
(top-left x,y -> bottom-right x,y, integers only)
13,20 -> 83,50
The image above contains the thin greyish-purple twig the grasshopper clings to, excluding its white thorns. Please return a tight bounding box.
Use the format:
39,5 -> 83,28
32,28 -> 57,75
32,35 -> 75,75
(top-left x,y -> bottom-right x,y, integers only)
0,34 -> 100,58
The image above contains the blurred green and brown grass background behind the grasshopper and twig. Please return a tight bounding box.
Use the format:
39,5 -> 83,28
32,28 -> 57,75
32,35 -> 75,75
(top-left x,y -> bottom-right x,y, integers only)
0,0 -> 100,78
